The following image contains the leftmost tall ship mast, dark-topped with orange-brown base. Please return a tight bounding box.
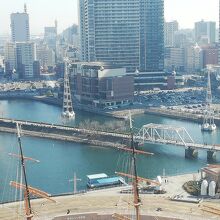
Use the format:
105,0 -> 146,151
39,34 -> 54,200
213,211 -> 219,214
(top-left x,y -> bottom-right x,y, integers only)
16,123 -> 33,220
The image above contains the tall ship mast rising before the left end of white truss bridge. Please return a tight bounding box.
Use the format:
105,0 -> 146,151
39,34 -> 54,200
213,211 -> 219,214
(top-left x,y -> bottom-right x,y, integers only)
129,113 -> 141,220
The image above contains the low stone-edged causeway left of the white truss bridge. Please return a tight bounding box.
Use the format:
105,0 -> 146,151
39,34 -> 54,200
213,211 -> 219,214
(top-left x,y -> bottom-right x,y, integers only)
0,119 -> 129,148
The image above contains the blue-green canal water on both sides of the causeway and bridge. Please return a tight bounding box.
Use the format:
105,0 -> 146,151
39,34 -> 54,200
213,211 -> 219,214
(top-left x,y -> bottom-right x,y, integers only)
0,100 -> 220,202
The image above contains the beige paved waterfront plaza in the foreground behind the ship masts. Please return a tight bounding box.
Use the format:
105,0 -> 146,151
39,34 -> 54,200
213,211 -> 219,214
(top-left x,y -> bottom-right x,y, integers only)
0,174 -> 220,220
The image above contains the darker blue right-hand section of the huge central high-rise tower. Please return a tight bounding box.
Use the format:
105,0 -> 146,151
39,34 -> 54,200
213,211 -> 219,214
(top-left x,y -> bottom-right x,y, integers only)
139,0 -> 164,72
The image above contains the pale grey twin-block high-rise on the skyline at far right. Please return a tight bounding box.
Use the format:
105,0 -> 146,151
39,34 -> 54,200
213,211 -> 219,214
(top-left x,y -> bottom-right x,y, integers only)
195,20 -> 216,44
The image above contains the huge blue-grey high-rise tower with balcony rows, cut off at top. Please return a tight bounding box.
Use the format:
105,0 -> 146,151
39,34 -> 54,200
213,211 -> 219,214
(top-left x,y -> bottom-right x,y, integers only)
79,0 -> 164,72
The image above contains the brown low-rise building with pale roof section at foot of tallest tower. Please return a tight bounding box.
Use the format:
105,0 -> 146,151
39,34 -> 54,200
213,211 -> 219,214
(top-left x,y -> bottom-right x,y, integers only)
71,62 -> 134,108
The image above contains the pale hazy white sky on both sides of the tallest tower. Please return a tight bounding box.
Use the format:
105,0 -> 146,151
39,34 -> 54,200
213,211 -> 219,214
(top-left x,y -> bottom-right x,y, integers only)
0,0 -> 218,34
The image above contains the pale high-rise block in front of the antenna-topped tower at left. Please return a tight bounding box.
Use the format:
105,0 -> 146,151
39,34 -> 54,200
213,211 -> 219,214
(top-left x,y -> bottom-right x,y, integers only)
16,42 -> 36,79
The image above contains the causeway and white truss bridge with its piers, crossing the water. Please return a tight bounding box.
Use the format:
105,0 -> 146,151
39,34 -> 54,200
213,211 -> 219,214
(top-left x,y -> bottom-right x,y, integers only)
0,118 -> 217,159
